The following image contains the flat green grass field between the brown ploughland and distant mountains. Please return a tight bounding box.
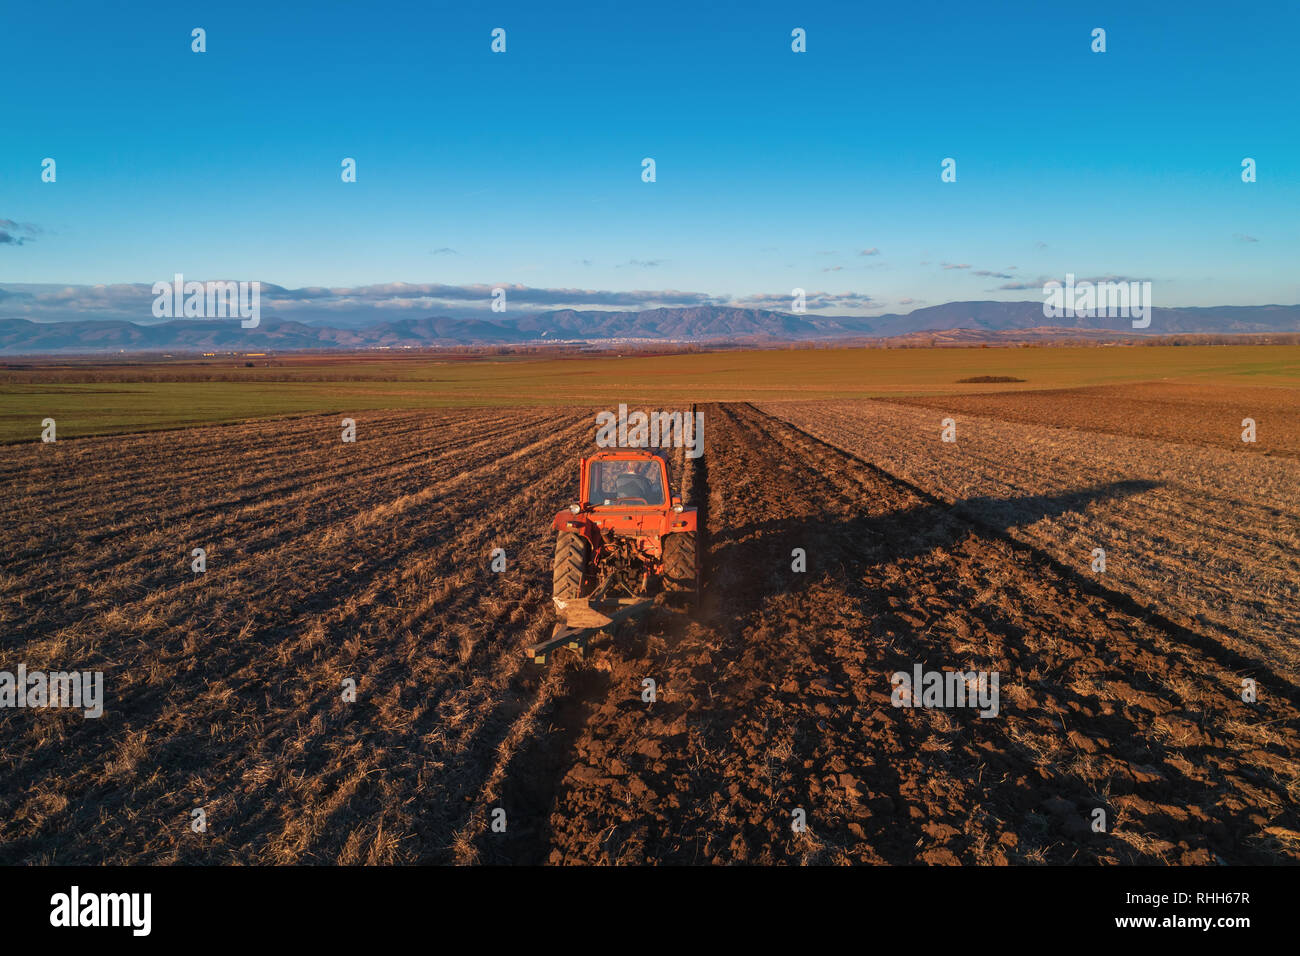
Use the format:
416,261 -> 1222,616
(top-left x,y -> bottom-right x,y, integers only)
0,346 -> 1300,444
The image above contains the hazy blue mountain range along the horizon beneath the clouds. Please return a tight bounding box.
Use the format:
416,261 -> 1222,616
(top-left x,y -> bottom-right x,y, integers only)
0,302 -> 1300,355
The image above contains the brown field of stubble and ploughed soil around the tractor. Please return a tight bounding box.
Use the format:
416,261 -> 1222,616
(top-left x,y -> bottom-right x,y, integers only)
0,393 -> 1300,864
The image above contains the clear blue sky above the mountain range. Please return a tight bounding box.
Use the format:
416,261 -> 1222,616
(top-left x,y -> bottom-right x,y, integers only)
0,3 -> 1300,321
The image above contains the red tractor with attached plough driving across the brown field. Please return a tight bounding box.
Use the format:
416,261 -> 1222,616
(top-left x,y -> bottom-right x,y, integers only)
551,449 -> 703,655
